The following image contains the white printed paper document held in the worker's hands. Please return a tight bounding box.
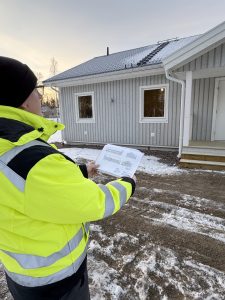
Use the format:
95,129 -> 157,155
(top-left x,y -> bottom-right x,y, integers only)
95,144 -> 144,177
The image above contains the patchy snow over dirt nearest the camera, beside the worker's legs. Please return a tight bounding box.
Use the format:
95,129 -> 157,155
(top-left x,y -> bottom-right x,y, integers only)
88,221 -> 225,300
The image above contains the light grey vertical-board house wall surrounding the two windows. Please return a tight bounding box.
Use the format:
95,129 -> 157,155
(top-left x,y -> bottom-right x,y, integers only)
60,75 -> 181,147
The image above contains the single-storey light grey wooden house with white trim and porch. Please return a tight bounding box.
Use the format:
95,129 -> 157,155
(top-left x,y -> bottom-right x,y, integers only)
44,22 -> 225,169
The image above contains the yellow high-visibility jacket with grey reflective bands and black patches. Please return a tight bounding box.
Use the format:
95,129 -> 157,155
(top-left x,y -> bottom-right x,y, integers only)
0,106 -> 134,287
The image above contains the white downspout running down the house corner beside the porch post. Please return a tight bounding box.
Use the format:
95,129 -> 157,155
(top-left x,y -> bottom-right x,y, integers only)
166,70 -> 185,158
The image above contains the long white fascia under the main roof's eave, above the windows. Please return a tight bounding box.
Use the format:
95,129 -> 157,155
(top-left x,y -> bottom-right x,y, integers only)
44,64 -> 165,87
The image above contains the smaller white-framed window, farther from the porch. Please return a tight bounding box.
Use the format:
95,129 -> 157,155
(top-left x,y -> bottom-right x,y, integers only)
75,92 -> 95,123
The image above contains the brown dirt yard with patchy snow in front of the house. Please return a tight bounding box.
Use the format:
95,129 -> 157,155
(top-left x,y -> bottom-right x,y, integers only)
0,152 -> 225,300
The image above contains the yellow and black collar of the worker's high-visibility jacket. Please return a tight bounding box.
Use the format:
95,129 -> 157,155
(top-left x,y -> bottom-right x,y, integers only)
0,105 -> 65,154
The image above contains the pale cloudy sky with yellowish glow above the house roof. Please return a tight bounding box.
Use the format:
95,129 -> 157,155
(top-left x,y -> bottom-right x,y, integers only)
0,0 -> 225,78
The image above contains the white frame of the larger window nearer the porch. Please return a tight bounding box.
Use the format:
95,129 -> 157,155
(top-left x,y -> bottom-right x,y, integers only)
139,83 -> 169,123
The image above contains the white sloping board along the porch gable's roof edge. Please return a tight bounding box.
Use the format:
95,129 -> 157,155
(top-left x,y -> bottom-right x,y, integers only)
163,22 -> 225,70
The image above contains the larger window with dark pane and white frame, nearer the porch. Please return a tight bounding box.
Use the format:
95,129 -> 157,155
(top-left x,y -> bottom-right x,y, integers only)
140,84 -> 168,123
